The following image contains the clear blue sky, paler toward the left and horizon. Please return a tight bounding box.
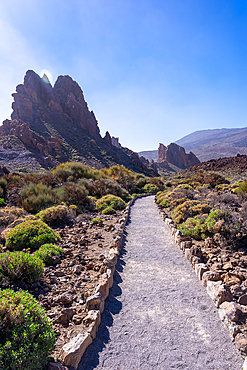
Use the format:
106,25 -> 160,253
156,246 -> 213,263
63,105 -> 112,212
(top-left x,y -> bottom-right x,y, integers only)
0,0 -> 247,151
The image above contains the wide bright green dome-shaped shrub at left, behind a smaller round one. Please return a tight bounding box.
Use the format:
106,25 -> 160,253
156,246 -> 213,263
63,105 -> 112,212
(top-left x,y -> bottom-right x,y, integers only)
6,220 -> 60,250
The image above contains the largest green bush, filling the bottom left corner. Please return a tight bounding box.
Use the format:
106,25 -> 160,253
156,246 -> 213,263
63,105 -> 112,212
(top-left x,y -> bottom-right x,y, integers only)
0,289 -> 55,370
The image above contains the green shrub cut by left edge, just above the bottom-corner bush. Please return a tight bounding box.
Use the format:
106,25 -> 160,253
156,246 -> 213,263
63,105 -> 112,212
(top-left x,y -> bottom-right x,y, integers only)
0,252 -> 44,284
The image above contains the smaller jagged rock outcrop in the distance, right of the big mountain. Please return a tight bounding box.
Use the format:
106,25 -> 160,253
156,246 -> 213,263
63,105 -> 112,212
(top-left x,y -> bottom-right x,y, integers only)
157,143 -> 200,168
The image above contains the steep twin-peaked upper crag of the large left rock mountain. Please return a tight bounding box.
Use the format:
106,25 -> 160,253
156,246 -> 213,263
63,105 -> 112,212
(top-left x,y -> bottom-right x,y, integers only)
11,71 -> 100,139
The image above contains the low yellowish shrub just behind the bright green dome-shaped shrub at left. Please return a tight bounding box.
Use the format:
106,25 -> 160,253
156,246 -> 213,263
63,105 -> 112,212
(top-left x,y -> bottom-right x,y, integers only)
34,205 -> 73,226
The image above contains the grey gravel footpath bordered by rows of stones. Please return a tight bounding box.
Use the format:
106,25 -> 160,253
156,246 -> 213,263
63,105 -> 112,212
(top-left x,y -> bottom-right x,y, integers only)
78,196 -> 243,370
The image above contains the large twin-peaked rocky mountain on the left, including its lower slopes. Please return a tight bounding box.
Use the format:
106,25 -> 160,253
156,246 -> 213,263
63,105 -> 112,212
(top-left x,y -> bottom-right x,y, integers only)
0,71 -> 156,175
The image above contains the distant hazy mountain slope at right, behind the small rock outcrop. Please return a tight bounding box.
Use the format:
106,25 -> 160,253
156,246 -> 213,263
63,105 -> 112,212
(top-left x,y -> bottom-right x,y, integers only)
176,127 -> 247,162
